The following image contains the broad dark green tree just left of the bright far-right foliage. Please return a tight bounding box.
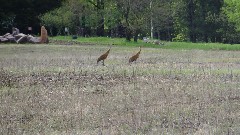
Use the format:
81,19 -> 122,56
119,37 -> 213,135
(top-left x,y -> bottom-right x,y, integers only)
174,0 -> 223,42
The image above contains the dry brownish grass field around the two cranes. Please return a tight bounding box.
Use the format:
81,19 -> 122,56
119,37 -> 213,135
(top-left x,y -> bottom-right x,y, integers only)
0,44 -> 240,135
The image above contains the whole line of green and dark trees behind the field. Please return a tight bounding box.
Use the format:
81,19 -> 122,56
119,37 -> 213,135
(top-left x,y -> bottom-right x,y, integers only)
0,0 -> 240,43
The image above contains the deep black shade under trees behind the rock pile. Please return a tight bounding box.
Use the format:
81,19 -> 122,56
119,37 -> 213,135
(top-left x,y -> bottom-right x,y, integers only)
0,0 -> 63,34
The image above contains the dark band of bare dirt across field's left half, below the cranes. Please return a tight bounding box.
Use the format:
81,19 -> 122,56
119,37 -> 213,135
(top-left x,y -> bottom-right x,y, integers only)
0,70 -> 135,87
